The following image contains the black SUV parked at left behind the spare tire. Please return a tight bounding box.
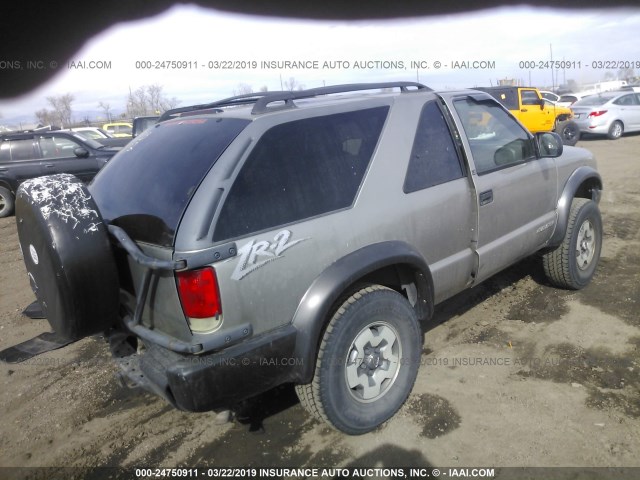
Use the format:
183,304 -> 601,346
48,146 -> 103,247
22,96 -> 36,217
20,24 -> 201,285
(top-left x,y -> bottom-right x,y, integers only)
0,131 -> 118,218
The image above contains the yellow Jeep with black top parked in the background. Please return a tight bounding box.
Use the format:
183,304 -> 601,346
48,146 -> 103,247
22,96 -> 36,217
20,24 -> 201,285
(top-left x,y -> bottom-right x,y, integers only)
477,87 -> 580,145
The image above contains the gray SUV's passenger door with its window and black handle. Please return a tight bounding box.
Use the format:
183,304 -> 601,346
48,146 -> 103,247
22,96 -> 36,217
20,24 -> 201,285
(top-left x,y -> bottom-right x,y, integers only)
453,95 -> 558,281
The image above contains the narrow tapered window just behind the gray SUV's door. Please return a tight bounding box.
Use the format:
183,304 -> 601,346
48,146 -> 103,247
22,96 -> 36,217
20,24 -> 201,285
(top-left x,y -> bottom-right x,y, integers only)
403,101 -> 463,193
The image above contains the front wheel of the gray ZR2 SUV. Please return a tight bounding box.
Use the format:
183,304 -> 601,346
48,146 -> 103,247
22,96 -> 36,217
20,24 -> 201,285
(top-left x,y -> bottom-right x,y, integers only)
542,198 -> 602,290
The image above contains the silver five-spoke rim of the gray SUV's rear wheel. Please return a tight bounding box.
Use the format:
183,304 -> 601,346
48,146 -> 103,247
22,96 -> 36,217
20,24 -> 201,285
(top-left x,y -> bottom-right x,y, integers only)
345,322 -> 402,403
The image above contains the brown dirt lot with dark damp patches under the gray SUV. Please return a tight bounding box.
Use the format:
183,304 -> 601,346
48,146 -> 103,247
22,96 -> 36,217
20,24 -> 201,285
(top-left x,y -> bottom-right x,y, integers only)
0,135 -> 640,477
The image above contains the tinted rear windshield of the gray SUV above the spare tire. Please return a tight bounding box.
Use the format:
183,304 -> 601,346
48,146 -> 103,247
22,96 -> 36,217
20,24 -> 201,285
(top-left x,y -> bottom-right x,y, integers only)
90,118 -> 249,246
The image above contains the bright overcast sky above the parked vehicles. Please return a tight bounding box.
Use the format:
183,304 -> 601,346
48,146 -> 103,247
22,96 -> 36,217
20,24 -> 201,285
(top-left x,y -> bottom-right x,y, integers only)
0,6 -> 640,124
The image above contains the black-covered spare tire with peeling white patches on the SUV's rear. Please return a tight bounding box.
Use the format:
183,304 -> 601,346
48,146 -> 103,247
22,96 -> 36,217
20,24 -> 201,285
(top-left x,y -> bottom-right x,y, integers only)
16,174 -> 120,340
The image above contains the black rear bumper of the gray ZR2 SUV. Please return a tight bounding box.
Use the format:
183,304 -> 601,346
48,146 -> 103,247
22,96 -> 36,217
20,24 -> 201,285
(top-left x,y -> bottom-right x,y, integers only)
116,325 -> 305,412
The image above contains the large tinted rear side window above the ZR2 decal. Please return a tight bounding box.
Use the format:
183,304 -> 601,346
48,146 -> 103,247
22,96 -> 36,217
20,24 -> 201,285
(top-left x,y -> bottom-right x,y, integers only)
214,107 -> 389,240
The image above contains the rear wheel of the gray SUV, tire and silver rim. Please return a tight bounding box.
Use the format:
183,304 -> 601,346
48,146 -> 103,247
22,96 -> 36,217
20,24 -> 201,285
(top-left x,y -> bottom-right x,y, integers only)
296,285 -> 422,435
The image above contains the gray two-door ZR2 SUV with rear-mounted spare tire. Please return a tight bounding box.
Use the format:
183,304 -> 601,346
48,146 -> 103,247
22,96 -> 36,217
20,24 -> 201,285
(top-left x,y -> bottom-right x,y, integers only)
17,82 -> 602,434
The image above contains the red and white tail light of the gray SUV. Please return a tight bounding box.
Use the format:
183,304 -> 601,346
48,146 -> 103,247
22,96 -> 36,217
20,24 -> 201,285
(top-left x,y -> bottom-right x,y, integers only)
176,267 -> 222,333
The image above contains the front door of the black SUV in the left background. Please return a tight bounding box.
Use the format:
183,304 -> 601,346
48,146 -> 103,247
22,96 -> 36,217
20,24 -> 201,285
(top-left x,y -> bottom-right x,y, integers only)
38,135 -> 100,182
